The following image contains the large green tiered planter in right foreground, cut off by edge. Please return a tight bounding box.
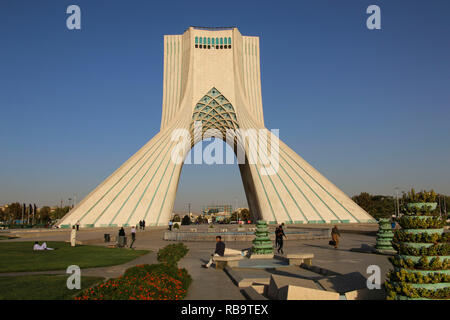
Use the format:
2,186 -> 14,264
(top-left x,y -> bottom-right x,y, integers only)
386,203 -> 450,300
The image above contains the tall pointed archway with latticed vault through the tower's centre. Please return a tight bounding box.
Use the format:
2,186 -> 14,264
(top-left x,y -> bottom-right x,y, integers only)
174,87 -> 259,224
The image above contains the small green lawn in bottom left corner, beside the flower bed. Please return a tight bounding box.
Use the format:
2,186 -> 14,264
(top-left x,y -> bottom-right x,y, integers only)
0,275 -> 103,300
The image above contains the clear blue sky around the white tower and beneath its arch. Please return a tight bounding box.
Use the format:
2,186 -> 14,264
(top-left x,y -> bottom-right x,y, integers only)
0,0 -> 450,210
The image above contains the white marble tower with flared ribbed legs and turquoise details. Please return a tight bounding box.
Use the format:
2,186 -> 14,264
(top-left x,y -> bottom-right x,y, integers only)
59,27 -> 374,228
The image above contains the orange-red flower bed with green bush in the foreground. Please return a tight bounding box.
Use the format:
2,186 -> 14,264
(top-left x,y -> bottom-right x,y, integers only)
75,244 -> 192,300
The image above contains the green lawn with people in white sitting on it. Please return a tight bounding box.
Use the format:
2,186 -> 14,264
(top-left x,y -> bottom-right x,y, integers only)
0,241 -> 150,272
